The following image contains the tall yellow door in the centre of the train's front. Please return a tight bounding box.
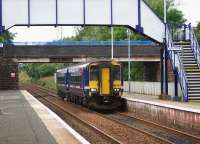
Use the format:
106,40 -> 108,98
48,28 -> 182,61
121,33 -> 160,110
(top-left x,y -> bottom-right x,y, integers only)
101,68 -> 110,95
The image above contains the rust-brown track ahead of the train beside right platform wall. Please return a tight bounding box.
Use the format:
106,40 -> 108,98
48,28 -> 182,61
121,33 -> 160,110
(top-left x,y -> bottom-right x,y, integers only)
103,113 -> 200,144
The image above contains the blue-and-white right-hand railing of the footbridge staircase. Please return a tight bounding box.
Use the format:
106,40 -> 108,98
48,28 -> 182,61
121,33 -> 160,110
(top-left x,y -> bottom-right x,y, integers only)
190,26 -> 200,67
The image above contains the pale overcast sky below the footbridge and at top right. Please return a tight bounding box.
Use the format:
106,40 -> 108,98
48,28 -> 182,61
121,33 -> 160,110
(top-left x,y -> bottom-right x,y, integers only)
10,0 -> 200,42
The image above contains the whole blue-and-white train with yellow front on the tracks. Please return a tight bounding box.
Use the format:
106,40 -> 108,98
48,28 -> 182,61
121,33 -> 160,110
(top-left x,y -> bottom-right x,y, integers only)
55,61 -> 123,110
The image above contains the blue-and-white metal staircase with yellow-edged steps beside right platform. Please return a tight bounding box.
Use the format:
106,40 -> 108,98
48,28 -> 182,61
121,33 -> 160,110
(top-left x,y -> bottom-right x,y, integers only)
166,24 -> 200,101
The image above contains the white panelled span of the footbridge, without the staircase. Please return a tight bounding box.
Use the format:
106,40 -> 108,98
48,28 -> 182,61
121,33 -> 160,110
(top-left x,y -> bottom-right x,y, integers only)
0,0 -> 164,42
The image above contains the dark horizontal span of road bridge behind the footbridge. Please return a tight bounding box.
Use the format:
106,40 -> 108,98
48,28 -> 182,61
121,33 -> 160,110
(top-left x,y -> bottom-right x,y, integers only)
4,44 -> 161,58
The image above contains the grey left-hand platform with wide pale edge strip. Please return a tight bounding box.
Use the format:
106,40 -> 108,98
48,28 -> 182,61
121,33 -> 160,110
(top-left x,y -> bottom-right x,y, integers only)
0,90 -> 89,144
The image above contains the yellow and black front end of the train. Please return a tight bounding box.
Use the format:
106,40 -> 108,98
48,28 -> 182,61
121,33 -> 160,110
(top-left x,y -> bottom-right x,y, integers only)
89,62 -> 123,109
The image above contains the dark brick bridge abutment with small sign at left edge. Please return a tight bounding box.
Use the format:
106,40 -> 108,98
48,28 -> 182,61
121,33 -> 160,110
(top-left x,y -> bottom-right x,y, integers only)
0,57 -> 19,90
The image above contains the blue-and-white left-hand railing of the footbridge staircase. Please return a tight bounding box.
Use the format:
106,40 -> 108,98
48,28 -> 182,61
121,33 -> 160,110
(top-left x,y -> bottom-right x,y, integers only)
166,26 -> 188,101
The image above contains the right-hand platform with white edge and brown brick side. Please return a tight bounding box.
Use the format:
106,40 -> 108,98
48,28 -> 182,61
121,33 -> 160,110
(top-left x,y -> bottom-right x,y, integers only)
123,92 -> 200,136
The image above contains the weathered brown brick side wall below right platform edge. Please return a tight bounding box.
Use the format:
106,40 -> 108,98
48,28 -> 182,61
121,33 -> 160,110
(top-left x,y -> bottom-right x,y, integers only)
127,100 -> 200,135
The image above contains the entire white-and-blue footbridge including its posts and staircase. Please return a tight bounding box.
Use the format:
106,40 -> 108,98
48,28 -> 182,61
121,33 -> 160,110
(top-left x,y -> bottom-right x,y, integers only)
0,0 -> 200,101
